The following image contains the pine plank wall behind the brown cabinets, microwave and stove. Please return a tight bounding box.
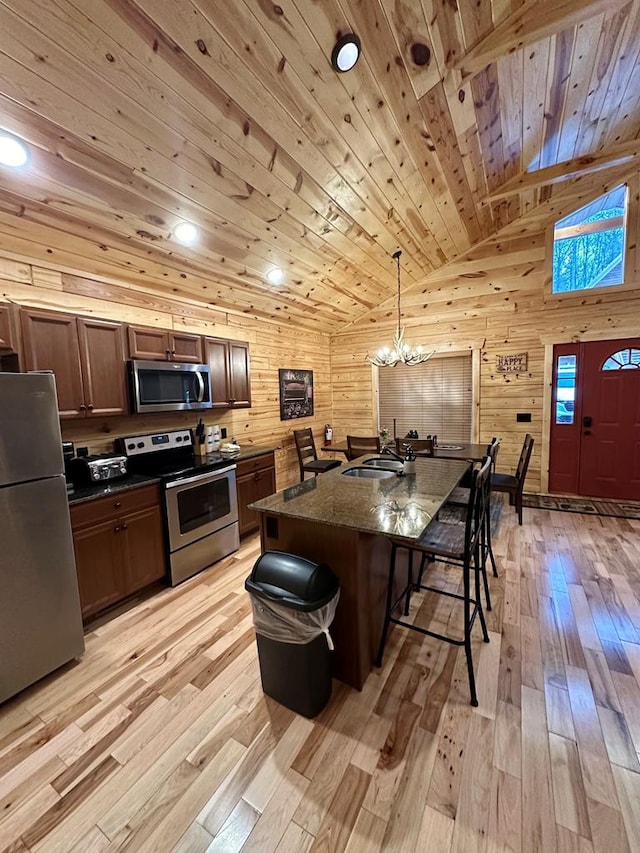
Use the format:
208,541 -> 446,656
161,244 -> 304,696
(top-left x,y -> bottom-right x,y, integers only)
0,256 -> 331,488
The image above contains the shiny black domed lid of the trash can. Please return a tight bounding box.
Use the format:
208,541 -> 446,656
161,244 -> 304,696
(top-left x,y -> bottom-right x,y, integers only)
244,551 -> 340,611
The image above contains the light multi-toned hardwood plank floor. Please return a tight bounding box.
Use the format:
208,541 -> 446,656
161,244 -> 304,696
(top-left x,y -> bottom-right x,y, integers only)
0,508 -> 640,853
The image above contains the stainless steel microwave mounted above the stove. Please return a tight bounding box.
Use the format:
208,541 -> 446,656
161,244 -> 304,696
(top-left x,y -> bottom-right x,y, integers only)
128,360 -> 211,412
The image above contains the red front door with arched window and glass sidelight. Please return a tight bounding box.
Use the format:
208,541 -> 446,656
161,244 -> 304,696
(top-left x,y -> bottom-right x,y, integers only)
549,338 -> 640,500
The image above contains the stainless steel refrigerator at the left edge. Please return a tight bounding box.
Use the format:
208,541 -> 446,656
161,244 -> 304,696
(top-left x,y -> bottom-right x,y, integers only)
0,373 -> 84,702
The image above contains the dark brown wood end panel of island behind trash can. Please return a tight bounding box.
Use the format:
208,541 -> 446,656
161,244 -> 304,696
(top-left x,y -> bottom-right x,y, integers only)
260,512 -> 391,690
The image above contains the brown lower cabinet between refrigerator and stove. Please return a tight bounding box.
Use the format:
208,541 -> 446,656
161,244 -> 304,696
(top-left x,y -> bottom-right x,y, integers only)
71,485 -> 166,620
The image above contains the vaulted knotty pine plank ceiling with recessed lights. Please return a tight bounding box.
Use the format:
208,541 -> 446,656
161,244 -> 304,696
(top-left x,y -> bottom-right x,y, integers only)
0,0 -> 640,333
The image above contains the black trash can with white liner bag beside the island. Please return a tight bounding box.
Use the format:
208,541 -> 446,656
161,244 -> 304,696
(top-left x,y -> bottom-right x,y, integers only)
244,551 -> 340,717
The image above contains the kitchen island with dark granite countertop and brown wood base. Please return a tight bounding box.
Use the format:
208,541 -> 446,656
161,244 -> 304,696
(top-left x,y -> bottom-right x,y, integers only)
251,455 -> 469,690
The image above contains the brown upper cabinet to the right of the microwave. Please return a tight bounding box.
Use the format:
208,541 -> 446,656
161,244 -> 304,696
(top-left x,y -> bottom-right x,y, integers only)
204,338 -> 251,409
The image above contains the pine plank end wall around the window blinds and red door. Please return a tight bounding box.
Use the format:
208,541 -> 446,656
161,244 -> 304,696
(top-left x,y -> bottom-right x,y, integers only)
331,233 -> 640,492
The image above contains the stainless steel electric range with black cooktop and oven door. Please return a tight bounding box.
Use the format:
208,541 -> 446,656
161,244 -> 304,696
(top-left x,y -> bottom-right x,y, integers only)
115,429 -> 240,586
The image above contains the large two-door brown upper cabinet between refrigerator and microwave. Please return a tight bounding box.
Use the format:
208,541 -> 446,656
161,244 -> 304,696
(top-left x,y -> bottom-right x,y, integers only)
20,309 -> 128,418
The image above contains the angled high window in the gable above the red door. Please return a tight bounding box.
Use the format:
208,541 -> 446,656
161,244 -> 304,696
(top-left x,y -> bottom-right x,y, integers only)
552,186 -> 628,293
